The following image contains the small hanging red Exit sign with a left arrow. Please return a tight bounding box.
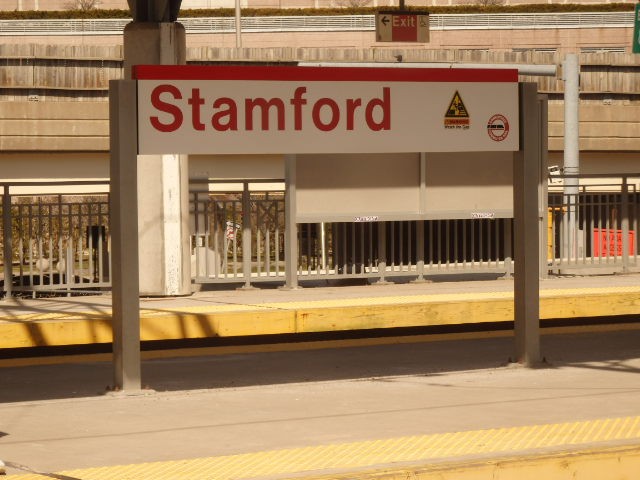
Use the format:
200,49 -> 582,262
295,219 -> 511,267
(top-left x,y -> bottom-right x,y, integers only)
376,11 -> 429,43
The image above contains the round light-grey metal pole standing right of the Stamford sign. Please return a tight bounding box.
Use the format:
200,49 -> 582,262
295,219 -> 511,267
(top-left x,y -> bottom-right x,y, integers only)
562,53 -> 580,261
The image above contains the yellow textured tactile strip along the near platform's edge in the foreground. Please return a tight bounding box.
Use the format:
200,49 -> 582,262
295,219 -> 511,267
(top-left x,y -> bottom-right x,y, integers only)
7,417 -> 640,480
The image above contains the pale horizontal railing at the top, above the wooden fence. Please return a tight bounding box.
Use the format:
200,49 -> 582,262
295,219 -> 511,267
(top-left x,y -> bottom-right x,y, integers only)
0,11 -> 633,36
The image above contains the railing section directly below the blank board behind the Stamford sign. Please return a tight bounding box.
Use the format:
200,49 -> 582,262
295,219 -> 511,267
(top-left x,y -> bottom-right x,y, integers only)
298,219 -> 512,281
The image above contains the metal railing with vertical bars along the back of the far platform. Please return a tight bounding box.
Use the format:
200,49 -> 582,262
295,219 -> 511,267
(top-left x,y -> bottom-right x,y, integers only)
0,174 -> 640,295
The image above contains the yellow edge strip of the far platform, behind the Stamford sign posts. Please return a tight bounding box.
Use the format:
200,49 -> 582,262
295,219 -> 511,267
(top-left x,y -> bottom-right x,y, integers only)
0,287 -> 640,348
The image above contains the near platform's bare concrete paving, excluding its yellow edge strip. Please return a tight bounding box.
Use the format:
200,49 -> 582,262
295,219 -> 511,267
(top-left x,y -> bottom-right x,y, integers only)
0,324 -> 640,478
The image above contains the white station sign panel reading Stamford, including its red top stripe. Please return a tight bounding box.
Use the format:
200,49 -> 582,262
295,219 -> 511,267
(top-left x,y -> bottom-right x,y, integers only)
134,66 -> 519,154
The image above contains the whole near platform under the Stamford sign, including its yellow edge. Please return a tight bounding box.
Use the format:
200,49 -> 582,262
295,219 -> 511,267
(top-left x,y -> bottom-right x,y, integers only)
0,302 -> 640,480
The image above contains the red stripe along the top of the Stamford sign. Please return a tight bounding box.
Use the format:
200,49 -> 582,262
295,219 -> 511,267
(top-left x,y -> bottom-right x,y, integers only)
132,65 -> 518,82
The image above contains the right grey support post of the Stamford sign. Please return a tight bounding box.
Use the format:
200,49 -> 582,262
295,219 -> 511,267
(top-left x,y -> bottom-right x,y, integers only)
513,83 -> 541,367
